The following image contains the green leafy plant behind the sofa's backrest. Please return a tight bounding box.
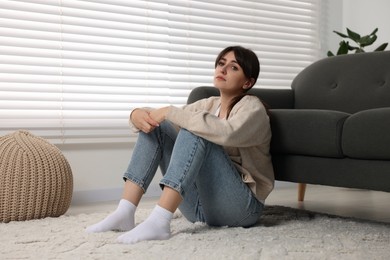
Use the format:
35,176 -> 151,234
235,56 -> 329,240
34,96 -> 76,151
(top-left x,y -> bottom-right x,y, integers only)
327,28 -> 388,57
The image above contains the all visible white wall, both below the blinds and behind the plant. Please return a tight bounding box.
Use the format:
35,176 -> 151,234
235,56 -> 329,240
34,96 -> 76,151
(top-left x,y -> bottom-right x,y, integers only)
58,0 -> 390,204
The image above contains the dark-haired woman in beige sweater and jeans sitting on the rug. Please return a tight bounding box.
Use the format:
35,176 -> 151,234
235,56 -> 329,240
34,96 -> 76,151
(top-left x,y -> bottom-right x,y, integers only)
87,46 -> 274,244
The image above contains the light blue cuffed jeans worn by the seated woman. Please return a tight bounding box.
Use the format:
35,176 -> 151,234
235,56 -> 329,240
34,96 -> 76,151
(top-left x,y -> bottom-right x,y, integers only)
124,121 -> 263,227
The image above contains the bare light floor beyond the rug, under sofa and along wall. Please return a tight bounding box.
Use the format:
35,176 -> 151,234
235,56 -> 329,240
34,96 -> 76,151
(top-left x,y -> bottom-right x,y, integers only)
67,185 -> 390,223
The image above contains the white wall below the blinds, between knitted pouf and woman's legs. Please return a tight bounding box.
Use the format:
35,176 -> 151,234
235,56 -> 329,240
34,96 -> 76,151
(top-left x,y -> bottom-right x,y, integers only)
57,143 -> 161,204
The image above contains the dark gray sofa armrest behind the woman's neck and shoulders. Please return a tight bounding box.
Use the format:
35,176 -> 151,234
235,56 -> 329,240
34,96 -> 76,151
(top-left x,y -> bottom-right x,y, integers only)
187,86 -> 294,109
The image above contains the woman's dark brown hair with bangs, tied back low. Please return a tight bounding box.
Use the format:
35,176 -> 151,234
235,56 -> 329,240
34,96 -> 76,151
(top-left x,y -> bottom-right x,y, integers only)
215,46 -> 260,118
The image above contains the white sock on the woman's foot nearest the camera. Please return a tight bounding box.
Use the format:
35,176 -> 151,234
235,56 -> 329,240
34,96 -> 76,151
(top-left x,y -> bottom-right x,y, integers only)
118,205 -> 173,244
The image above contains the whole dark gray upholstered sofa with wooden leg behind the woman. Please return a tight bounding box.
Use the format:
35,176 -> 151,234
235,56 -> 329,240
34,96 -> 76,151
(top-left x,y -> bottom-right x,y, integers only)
188,51 -> 390,200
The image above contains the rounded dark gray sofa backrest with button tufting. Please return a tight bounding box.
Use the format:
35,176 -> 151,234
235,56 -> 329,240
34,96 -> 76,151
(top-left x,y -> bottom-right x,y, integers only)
292,51 -> 390,113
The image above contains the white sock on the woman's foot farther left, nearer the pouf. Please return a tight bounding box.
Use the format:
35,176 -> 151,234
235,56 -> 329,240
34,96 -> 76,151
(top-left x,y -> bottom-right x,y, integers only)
86,199 -> 137,233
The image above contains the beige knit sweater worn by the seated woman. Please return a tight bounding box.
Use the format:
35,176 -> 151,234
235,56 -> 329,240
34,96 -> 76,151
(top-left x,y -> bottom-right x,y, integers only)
130,95 -> 274,203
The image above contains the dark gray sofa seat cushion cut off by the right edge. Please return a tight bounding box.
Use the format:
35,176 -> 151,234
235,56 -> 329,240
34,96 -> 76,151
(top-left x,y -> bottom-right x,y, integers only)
342,108 -> 390,160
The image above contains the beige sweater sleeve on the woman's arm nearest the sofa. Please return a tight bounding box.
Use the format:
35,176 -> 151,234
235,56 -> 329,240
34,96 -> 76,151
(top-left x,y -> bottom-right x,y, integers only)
167,96 -> 270,147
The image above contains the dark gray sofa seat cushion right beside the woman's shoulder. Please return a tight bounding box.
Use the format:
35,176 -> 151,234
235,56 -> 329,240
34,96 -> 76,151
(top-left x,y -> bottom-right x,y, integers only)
270,109 -> 349,158
